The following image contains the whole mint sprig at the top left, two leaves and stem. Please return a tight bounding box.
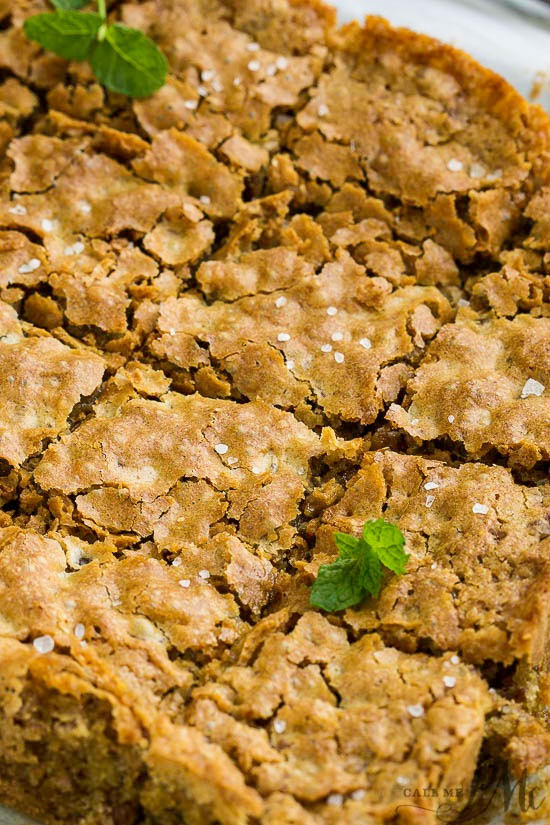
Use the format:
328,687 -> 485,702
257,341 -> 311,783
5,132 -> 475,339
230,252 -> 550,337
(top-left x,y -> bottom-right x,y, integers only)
24,0 -> 168,98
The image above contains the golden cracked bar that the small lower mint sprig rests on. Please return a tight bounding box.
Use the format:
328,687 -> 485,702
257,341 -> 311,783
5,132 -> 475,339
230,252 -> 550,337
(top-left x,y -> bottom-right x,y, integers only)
305,451 -> 550,665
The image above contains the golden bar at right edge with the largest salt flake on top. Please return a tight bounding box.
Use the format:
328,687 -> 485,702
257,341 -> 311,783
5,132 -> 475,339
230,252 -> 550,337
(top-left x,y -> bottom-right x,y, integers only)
387,311 -> 550,468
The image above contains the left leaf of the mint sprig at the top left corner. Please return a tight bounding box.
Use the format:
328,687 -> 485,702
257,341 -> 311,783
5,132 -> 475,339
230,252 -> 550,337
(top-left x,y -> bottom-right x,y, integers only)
24,11 -> 103,60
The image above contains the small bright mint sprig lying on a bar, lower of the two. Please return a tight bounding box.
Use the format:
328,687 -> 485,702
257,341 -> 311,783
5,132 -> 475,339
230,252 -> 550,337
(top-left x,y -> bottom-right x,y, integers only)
309,519 -> 409,612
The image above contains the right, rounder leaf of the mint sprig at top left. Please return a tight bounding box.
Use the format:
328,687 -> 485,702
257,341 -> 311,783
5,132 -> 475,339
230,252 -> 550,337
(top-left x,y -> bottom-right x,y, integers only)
89,23 -> 168,98
